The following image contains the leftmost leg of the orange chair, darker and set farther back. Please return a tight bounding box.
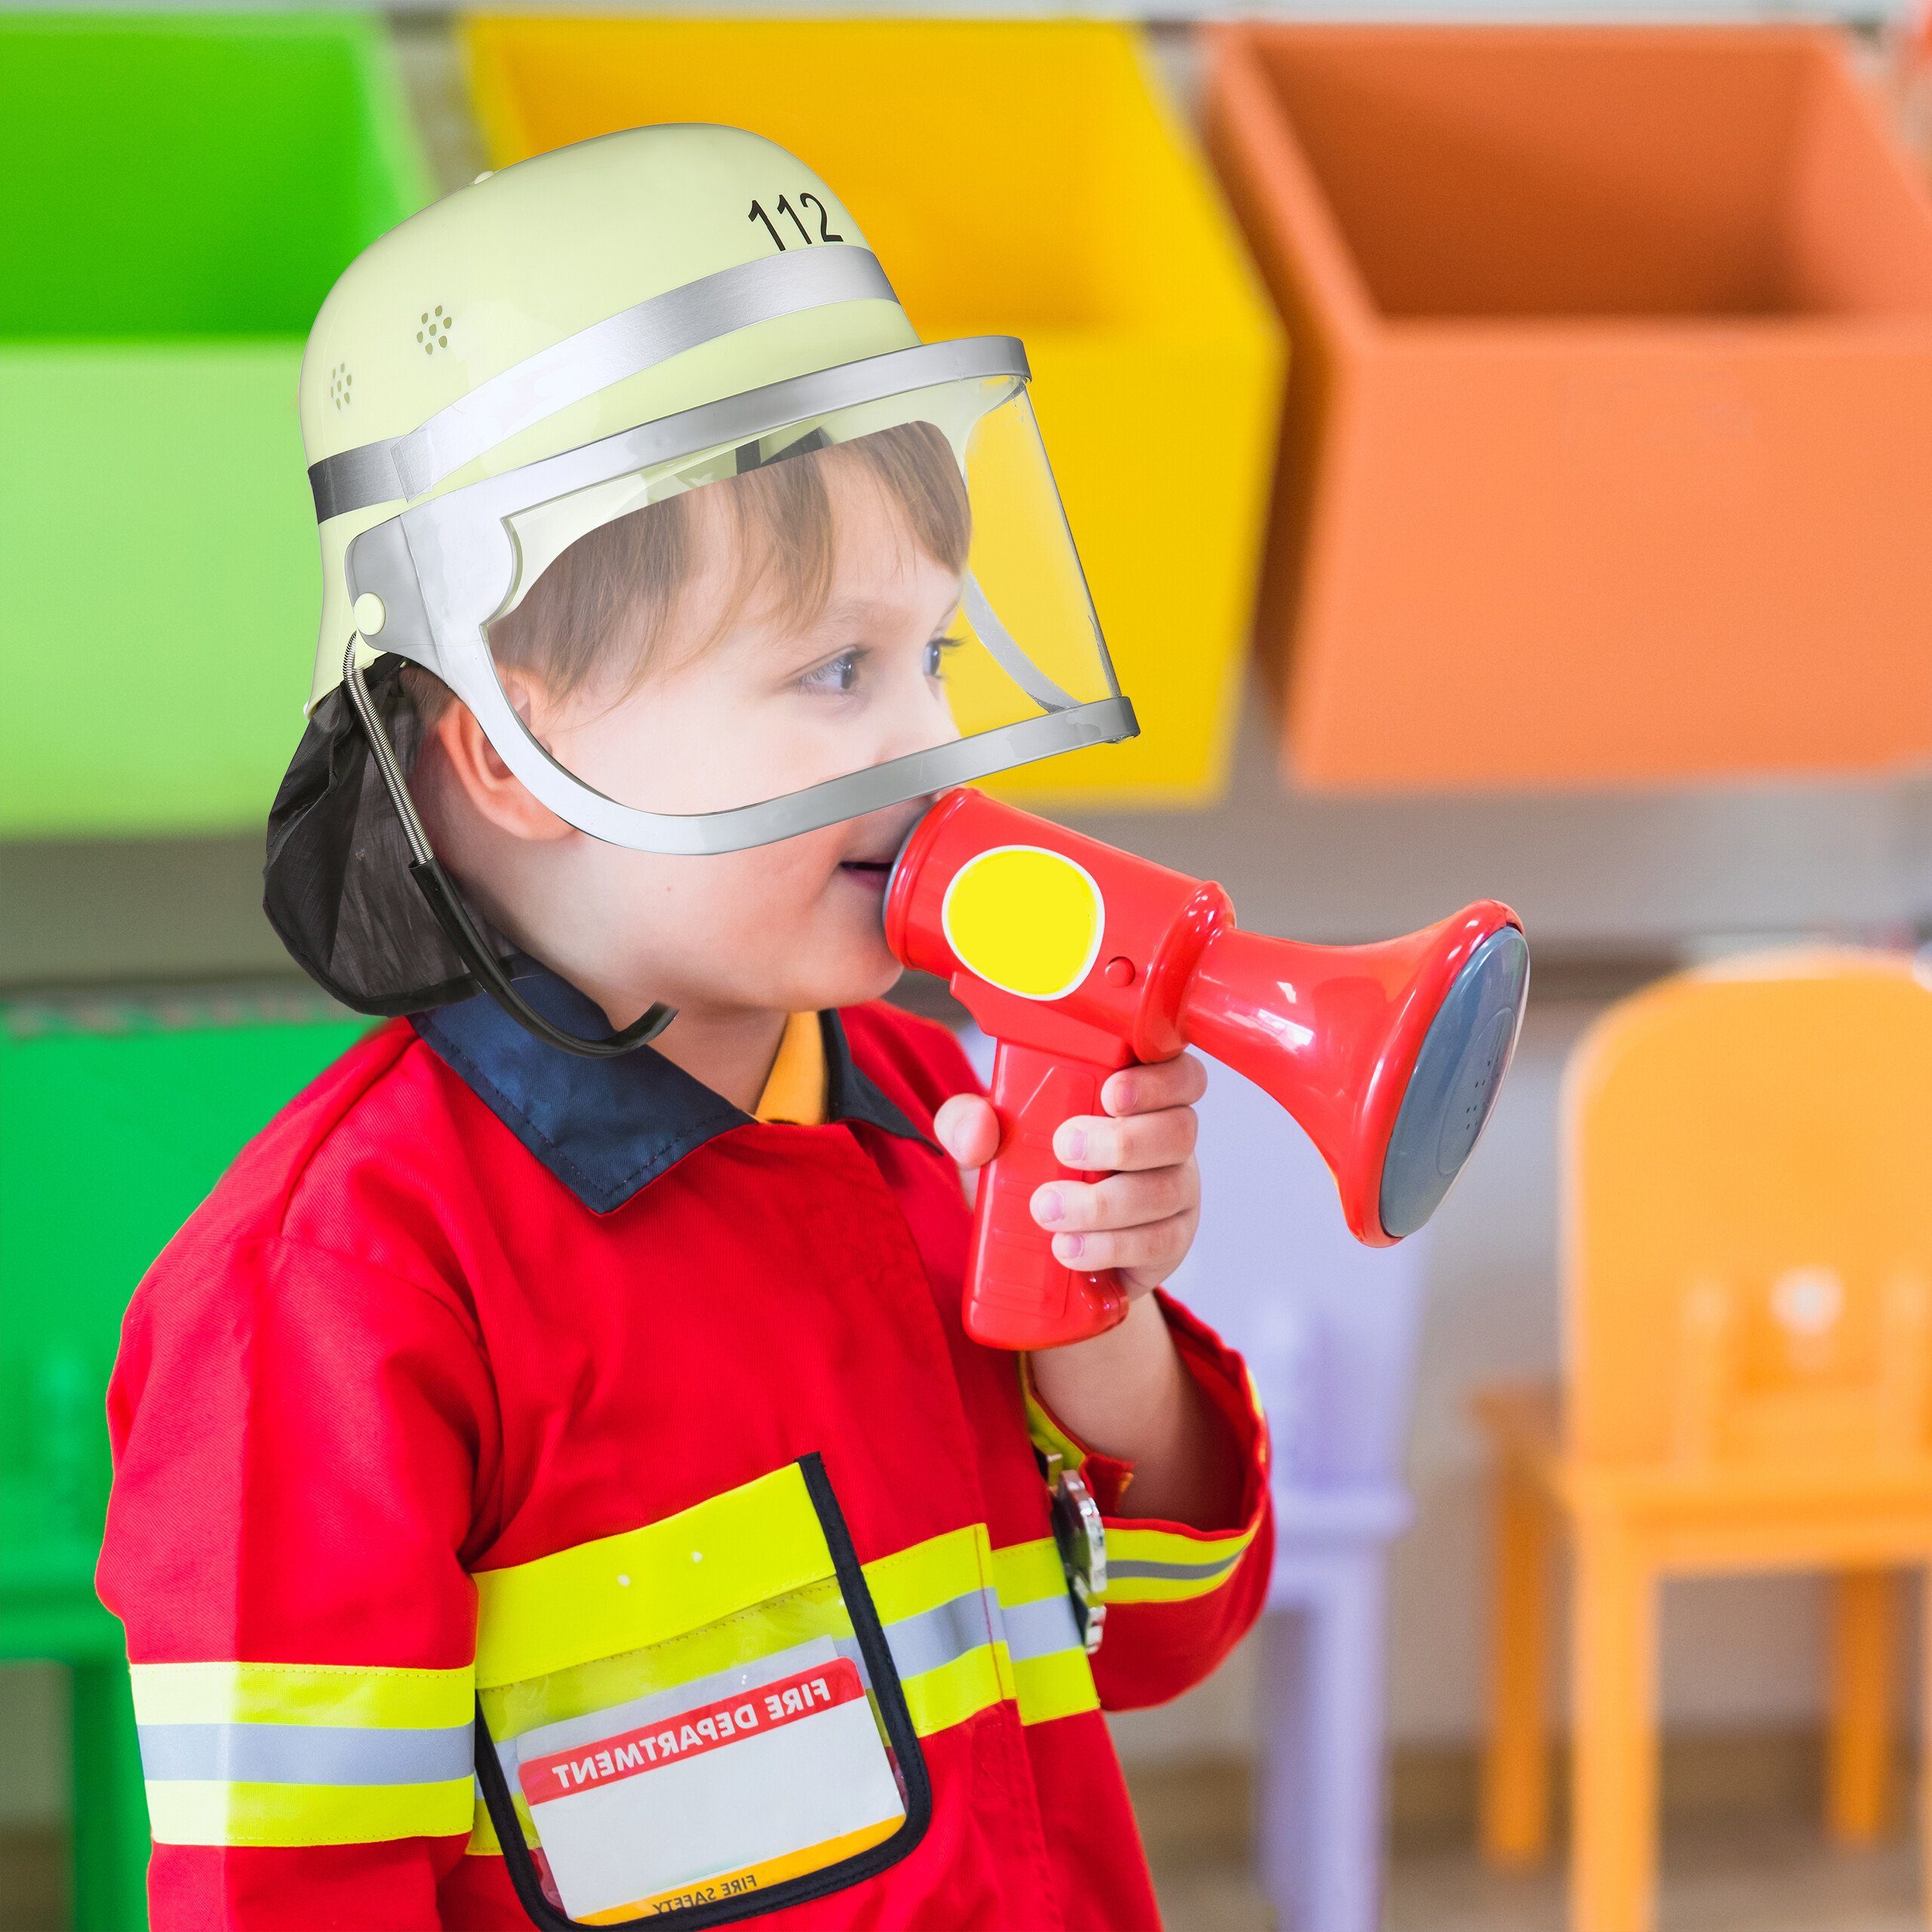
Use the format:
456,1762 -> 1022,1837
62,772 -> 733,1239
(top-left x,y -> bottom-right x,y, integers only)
1482,1451 -> 1549,1866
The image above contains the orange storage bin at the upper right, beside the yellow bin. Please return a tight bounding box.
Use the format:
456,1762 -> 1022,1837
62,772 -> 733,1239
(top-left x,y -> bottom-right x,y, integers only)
1205,25 -> 1932,788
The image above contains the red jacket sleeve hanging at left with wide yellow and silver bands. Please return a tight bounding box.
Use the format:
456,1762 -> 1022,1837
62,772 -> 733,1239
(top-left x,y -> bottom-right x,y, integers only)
97,1236 -> 494,1932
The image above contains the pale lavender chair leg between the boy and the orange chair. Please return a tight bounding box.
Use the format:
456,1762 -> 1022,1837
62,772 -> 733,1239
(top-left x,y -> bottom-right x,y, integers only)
1262,1546 -> 1387,1932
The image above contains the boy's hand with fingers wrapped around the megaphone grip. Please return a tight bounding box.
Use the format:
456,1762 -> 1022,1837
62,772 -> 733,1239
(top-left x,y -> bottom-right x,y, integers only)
933,1053 -> 1208,1297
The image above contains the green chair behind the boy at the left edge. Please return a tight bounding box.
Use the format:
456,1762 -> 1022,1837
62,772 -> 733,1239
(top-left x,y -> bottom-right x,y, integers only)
0,993 -> 369,1932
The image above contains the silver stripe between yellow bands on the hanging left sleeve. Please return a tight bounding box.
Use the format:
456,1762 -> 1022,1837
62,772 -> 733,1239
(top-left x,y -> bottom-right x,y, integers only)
141,1724 -> 475,1785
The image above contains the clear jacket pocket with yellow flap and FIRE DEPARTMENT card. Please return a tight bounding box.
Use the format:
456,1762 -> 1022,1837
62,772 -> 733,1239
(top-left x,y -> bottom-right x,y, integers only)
475,1455 -> 931,1928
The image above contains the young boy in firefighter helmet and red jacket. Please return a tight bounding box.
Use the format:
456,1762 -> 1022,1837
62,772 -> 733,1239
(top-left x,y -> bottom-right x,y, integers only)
100,128 -> 1269,1932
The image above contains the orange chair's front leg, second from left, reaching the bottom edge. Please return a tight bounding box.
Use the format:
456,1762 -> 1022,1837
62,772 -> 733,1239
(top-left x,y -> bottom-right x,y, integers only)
1571,1522 -> 1657,1932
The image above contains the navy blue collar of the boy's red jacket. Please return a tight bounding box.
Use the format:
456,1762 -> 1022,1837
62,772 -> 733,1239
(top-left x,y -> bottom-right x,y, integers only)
410,958 -> 924,1214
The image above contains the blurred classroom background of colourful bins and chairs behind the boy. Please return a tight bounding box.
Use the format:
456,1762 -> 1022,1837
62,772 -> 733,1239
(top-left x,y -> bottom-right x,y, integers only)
11,0 -> 1932,1932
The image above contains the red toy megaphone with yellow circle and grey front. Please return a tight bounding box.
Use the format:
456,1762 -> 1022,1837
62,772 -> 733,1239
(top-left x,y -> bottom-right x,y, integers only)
884,788 -> 1531,1349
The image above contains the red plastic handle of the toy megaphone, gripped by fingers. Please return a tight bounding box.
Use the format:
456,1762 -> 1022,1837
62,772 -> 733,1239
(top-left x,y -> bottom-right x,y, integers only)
966,1039 -> 1126,1349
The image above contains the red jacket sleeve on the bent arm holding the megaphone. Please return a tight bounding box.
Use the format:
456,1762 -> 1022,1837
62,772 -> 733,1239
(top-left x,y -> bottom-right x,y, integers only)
1022,1289 -> 1275,1710
